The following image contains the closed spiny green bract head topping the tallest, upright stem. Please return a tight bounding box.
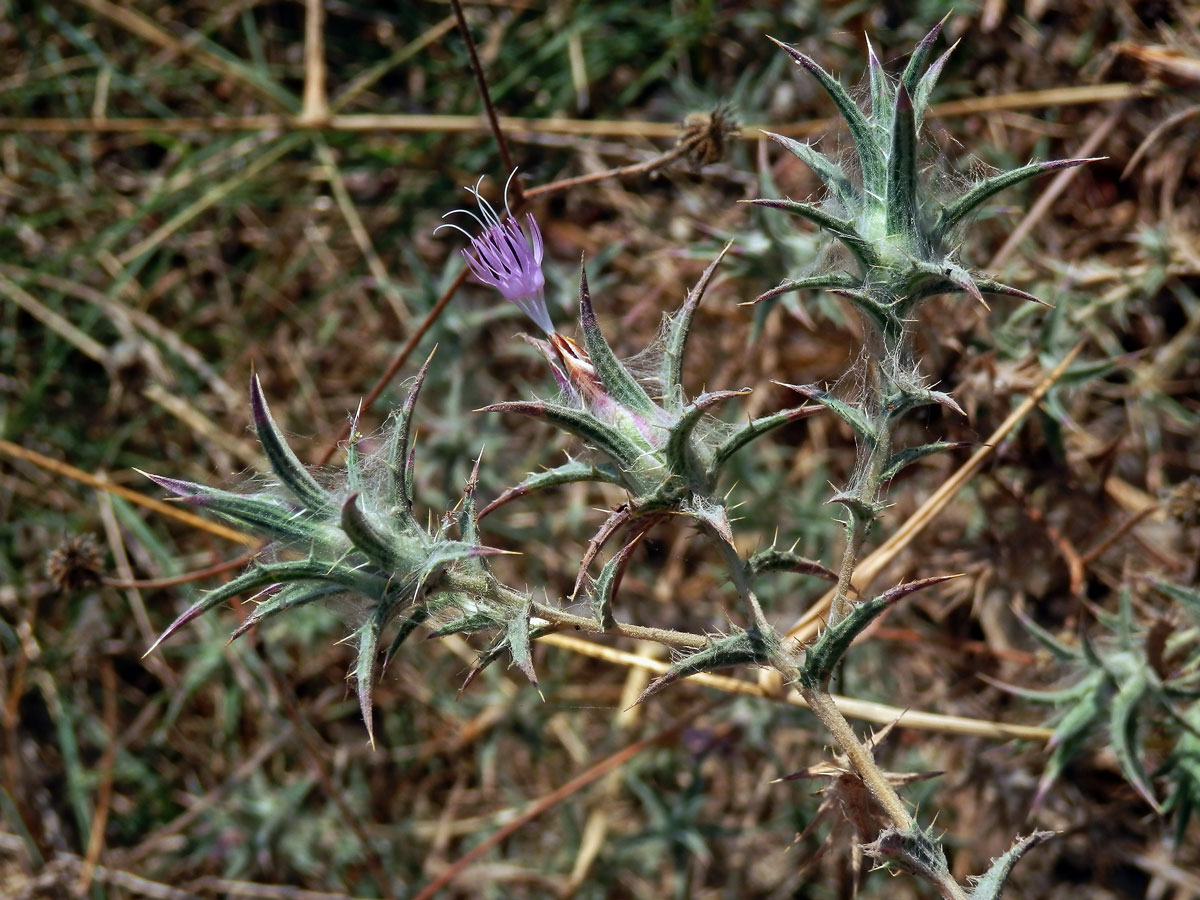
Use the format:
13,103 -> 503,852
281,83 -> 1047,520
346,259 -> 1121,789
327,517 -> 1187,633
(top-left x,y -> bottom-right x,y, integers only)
751,25 -> 1087,348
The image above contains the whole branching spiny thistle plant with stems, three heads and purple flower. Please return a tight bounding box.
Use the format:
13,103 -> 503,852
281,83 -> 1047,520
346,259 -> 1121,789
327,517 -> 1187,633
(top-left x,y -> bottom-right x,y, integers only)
140,26 -> 1123,900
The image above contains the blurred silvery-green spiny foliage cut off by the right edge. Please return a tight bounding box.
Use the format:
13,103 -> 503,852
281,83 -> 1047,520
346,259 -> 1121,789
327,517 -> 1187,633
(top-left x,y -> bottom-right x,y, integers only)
1001,584 -> 1200,836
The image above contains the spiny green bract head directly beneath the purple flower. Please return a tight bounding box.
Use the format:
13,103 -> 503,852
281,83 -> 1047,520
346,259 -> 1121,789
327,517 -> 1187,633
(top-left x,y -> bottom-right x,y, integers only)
481,247 -> 820,609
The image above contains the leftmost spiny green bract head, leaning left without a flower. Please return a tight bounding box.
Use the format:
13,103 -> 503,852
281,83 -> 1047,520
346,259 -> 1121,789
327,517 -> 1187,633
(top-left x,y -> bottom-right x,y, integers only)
143,360 -> 536,743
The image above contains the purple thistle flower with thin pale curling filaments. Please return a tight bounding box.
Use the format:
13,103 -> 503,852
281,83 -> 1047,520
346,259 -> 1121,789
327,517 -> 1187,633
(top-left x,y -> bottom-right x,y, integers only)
434,169 -> 554,335
